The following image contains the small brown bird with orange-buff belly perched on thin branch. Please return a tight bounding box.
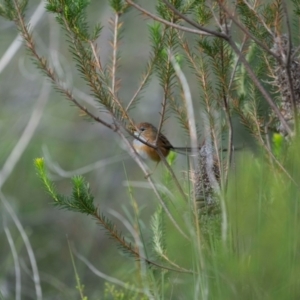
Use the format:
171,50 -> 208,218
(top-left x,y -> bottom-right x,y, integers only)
133,122 -> 191,163
